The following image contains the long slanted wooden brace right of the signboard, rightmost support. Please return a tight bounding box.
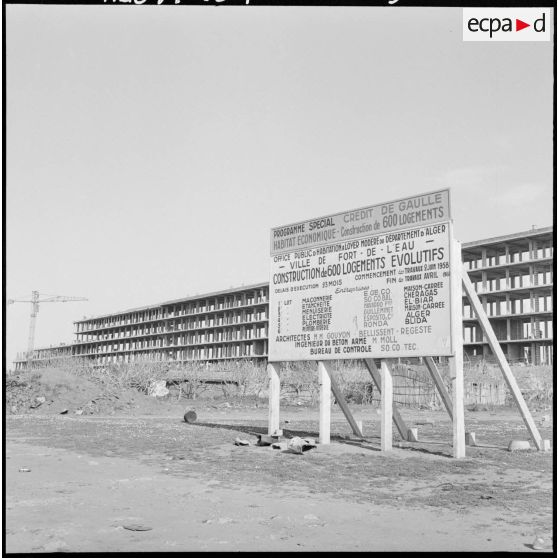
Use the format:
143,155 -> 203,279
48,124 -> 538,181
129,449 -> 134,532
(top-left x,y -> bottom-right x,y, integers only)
461,269 -> 543,450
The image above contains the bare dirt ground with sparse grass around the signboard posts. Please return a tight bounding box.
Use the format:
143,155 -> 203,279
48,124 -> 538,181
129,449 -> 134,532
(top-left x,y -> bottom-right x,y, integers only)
5,394 -> 554,552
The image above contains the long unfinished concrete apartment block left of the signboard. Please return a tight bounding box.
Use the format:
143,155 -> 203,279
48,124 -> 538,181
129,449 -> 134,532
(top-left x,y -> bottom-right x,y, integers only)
74,283 -> 268,364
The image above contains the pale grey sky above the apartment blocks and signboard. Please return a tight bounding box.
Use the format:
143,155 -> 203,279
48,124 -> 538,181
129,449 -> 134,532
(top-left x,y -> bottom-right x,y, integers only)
5,4 -> 554,367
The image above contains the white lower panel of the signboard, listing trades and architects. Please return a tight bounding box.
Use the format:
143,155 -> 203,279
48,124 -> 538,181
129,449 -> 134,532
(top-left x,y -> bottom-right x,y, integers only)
268,191 -> 453,362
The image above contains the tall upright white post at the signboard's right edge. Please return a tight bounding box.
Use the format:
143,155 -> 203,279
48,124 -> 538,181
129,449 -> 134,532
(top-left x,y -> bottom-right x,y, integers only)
449,234 -> 466,458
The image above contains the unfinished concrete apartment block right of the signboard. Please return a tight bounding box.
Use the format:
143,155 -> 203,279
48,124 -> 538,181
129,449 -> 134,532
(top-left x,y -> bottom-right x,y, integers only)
462,227 -> 554,364
